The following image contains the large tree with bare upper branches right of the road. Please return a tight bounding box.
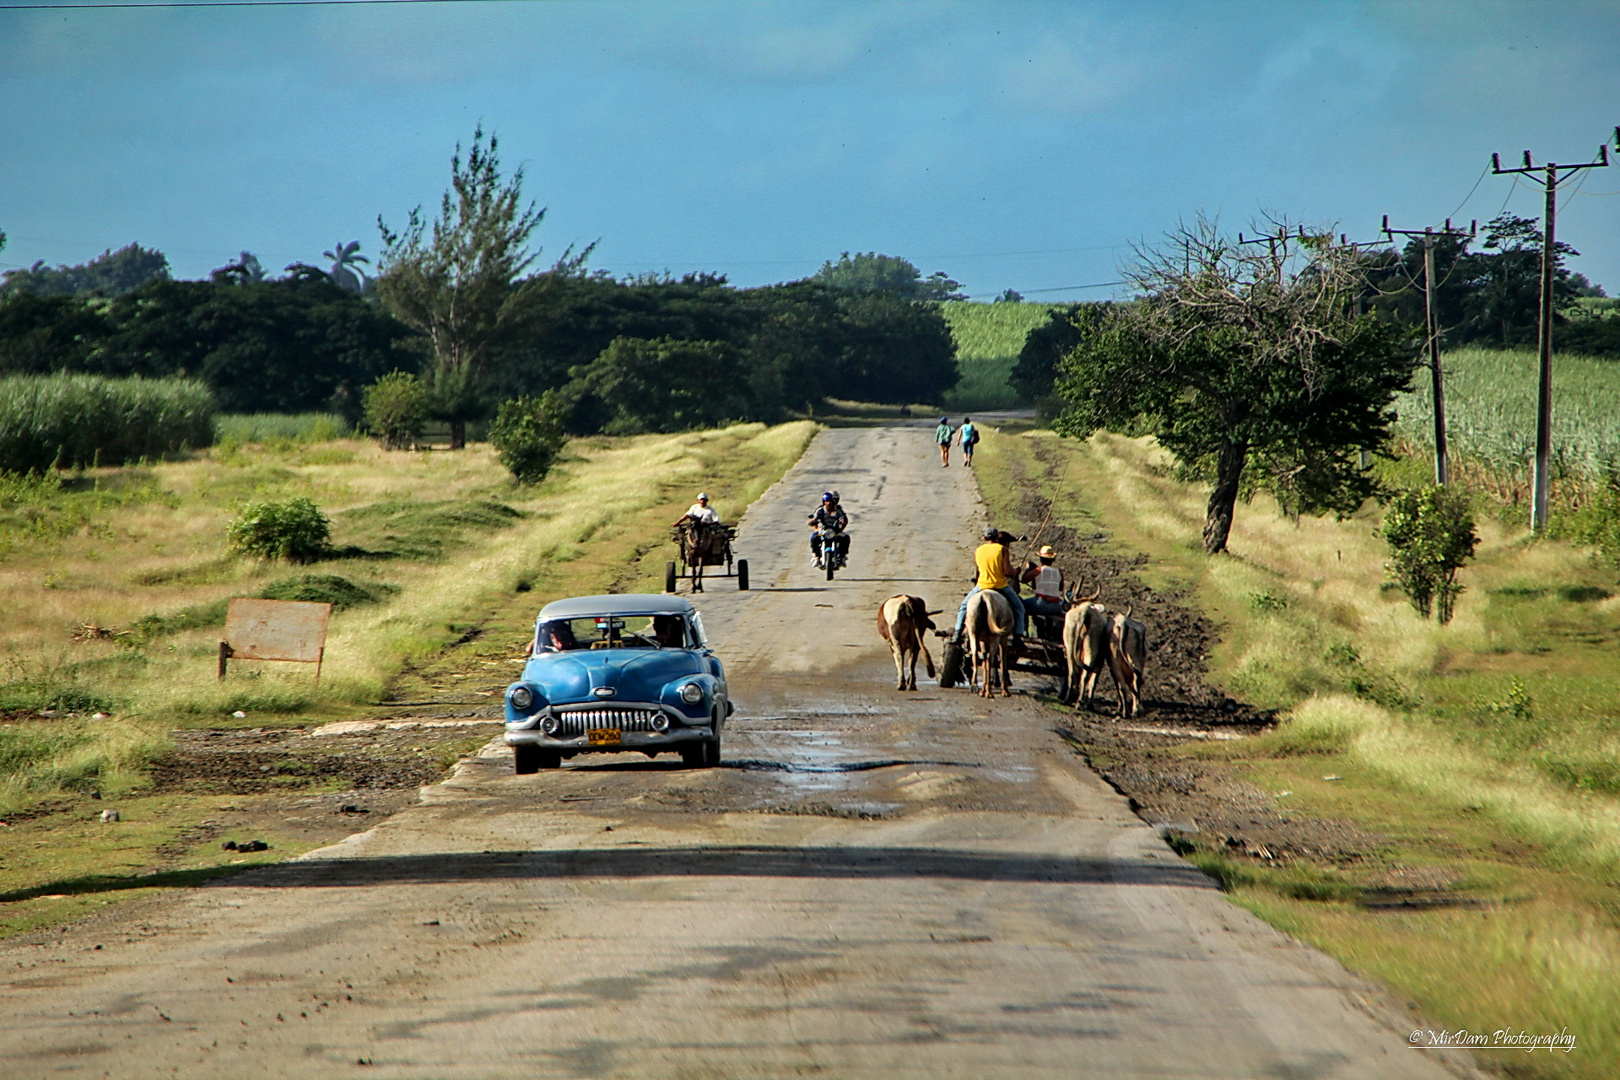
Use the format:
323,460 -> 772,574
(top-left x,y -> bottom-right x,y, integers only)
1055,220 -> 1416,554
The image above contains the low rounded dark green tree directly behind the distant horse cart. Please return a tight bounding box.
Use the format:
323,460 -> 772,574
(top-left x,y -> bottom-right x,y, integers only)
569,337 -> 748,436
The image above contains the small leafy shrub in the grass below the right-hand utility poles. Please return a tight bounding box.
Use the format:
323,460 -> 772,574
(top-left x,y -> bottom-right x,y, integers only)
1382,486 -> 1479,625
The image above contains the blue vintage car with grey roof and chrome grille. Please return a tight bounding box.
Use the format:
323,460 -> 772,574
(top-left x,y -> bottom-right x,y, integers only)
505,594 -> 732,772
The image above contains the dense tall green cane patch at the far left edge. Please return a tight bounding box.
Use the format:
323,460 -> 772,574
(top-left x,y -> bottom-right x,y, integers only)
0,374 -> 214,473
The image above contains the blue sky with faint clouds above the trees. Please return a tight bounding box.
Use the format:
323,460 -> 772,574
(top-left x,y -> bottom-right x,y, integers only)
0,0 -> 1620,300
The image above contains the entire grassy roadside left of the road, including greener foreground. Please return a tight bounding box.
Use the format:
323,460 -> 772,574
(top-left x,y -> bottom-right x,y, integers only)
0,423 -> 816,936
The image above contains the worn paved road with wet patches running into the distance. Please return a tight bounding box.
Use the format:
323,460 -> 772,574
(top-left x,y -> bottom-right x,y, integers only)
0,427 -> 1470,1080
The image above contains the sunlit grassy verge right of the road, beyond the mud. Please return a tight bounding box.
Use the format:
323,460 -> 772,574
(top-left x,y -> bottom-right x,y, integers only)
977,431 -> 1620,1077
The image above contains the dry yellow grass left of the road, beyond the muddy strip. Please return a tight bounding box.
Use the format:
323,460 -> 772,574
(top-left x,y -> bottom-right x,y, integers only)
0,423 -> 816,806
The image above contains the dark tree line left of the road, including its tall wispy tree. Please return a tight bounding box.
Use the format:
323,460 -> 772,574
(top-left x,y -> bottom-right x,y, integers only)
0,130 -> 959,444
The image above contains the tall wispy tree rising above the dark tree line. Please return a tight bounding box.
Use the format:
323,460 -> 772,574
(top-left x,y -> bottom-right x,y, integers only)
376,126 -> 590,447
